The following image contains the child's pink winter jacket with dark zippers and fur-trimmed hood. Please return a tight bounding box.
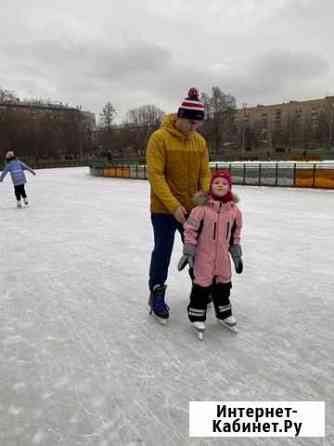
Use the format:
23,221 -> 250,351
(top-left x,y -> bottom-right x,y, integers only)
184,198 -> 242,287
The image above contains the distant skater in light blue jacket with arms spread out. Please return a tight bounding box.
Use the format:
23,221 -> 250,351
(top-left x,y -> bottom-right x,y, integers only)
0,150 -> 36,208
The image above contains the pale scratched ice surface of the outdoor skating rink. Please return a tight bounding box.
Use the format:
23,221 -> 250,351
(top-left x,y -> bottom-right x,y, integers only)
0,168 -> 334,446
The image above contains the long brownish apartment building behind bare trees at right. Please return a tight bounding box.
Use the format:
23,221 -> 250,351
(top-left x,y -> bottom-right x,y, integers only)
230,96 -> 334,158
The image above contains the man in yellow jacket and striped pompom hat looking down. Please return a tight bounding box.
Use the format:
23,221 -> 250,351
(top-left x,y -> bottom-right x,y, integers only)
146,88 -> 210,323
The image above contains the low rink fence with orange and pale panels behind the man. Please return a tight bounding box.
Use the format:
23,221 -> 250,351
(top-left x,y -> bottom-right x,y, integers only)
89,161 -> 334,189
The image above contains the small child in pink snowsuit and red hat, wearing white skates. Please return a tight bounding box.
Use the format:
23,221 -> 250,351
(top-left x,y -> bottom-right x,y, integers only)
178,171 -> 243,332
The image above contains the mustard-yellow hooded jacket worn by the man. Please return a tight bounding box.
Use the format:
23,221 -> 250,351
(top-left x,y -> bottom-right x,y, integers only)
146,114 -> 210,214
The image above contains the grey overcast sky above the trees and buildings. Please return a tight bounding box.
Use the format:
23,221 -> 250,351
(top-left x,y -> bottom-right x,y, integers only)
0,0 -> 334,120
